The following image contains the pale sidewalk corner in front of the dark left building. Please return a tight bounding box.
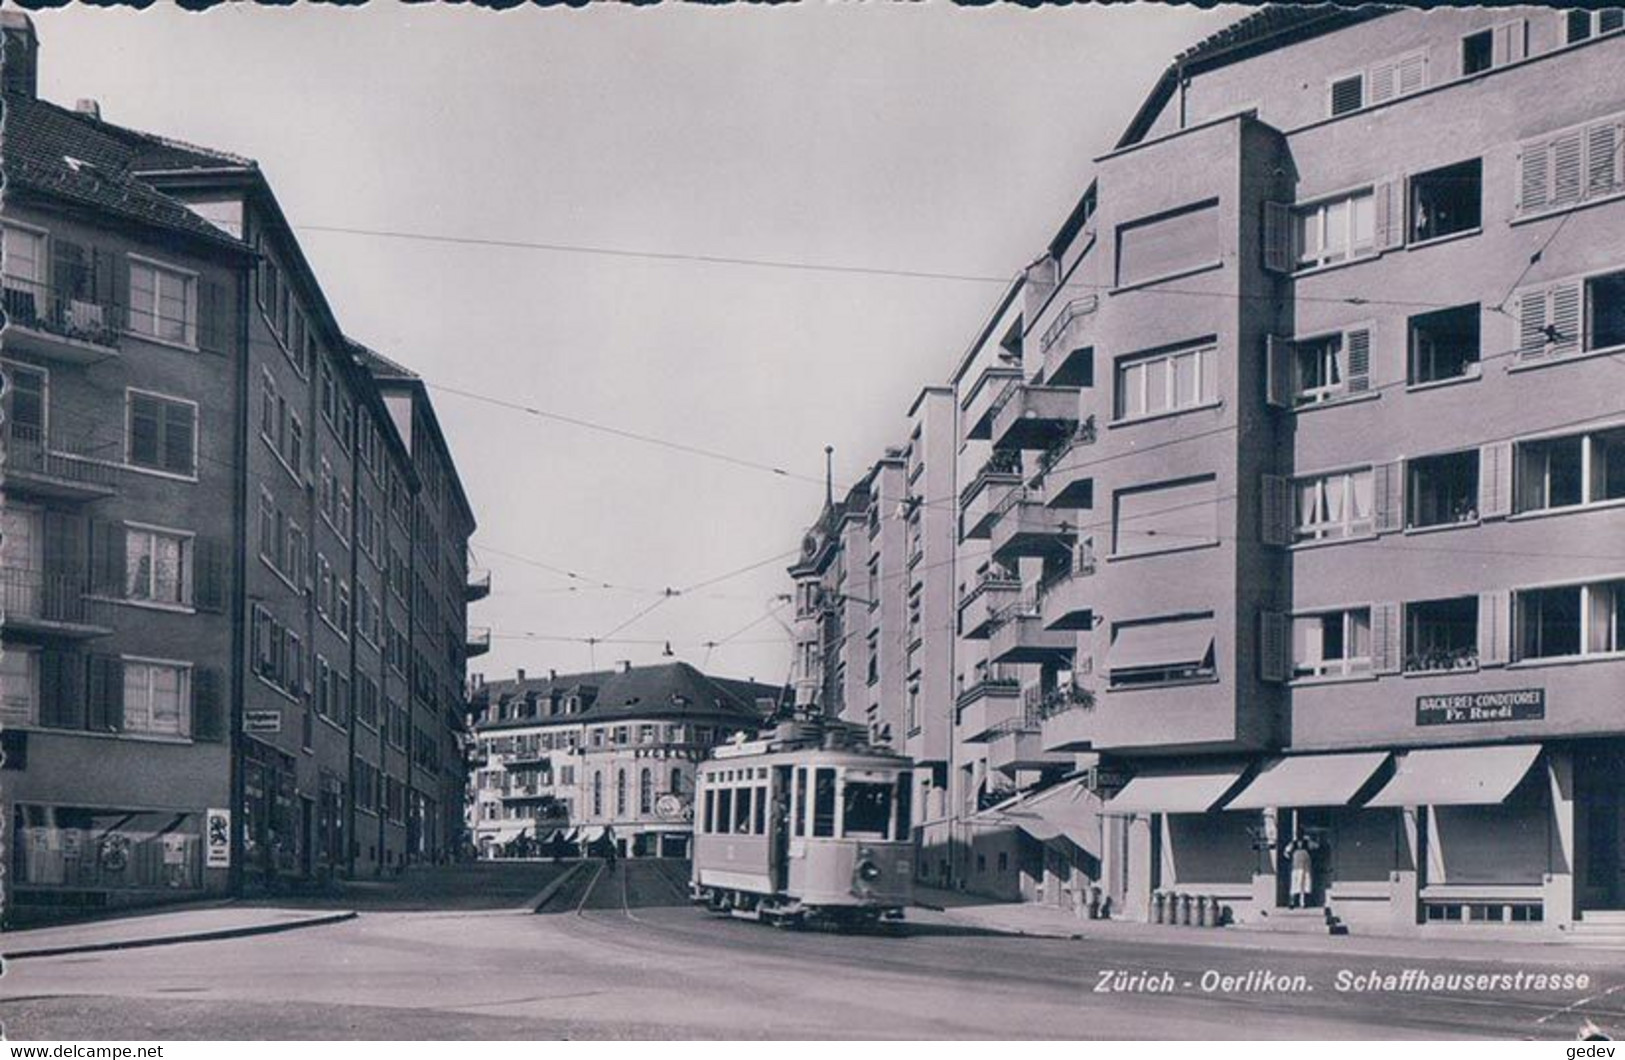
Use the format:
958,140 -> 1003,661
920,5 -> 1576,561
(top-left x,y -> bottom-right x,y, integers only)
0,904 -> 356,961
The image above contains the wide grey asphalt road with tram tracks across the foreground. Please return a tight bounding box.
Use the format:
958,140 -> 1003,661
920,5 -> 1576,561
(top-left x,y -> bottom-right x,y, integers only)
0,862 -> 1625,1040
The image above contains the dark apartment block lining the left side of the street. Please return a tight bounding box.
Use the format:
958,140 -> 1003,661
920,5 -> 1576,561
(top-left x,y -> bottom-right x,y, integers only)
3,16 -> 489,904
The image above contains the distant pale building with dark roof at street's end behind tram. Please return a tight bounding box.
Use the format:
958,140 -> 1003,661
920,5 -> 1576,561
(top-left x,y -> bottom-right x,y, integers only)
468,662 -> 787,857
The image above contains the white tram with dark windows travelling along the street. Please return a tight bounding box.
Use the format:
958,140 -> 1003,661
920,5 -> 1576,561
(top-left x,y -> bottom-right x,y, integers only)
691,720 -> 915,927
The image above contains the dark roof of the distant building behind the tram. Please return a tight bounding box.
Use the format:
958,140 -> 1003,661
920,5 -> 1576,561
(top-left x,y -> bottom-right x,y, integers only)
476,662 -> 783,730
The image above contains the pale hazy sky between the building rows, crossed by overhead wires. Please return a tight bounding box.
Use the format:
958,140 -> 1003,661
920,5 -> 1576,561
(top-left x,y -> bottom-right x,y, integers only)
34,2 -> 1245,681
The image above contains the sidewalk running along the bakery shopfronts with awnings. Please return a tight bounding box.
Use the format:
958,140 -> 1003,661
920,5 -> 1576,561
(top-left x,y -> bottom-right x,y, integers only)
908,884 -> 1625,969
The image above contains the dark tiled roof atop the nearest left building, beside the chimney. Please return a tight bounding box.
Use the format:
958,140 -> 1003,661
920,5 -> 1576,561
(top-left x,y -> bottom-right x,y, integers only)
0,96 -> 244,249
